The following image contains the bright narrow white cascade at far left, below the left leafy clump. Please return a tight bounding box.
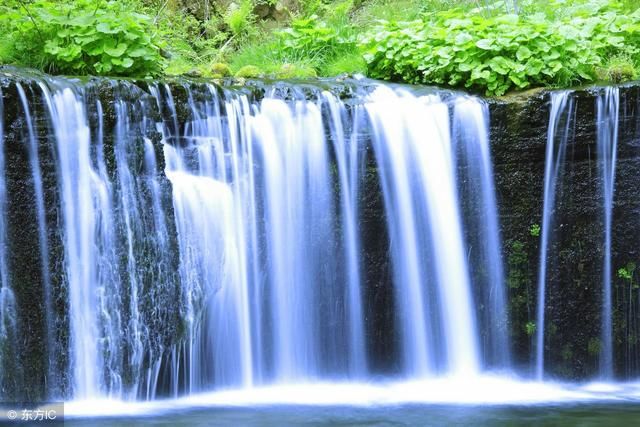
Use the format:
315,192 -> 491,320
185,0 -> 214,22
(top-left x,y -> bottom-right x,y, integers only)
44,88 -> 104,398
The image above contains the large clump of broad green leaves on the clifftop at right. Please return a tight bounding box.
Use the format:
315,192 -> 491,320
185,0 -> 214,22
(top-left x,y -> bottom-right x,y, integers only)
364,3 -> 640,95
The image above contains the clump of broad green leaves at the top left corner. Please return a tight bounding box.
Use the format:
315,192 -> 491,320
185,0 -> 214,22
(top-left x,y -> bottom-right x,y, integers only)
0,0 -> 164,76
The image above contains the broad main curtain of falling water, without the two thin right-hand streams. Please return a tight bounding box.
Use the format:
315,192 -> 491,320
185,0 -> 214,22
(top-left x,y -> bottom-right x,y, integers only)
0,72 -> 510,399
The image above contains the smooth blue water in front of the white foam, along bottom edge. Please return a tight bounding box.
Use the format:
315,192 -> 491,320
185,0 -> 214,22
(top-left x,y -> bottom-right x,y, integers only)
65,402 -> 640,427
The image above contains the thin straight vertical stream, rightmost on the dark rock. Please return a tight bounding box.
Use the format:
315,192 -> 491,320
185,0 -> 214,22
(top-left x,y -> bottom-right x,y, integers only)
596,87 -> 620,379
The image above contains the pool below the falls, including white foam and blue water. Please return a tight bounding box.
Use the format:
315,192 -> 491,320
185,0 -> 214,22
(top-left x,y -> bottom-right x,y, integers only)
65,376 -> 640,427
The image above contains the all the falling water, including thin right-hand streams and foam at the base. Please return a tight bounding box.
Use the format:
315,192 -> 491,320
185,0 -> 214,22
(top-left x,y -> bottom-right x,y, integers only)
0,70 -> 635,424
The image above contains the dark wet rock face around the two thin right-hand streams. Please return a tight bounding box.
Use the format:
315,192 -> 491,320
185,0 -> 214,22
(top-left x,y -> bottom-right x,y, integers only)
490,85 -> 640,379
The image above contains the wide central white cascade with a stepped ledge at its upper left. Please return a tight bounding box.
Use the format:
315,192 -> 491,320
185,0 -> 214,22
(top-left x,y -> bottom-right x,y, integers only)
154,87 -> 366,390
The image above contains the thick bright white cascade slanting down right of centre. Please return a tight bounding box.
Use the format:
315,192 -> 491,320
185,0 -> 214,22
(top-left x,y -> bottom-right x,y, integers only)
366,88 -> 480,377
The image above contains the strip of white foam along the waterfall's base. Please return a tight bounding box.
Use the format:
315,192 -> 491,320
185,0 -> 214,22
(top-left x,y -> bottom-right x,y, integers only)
65,375 -> 640,418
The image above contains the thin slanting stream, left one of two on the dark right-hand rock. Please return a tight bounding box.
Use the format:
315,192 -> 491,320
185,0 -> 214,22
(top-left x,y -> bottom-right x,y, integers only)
535,91 -> 574,380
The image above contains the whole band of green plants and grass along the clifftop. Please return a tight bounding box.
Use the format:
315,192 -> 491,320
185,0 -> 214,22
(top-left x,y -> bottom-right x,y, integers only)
0,0 -> 640,88
